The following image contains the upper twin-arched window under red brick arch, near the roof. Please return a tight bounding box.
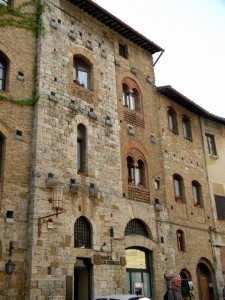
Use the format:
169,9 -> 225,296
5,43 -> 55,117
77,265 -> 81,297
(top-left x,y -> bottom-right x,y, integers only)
122,83 -> 140,110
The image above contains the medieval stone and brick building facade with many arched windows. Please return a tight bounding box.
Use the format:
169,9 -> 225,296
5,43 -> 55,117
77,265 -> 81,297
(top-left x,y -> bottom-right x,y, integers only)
0,0 -> 225,300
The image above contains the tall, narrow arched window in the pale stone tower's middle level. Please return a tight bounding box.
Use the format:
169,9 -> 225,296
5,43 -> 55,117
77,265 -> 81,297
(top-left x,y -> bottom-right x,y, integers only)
77,124 -> 86,173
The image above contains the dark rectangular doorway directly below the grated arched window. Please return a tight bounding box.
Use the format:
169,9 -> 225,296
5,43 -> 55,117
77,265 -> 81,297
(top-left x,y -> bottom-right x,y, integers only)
74,258 -> 92,300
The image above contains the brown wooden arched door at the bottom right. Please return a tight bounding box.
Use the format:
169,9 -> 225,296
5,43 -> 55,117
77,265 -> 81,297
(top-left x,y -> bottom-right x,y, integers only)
197,260 -> 215,300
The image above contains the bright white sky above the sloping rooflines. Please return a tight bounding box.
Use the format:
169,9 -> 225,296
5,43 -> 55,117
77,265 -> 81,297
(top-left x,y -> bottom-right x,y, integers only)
93,0 -> 225,118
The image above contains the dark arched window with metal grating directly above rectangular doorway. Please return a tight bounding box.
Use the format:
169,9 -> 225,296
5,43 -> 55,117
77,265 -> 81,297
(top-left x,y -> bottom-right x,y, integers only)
74,217 -> 91,249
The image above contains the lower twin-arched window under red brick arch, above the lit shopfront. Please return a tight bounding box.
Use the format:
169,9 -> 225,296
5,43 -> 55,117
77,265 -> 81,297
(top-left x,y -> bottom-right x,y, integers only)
127,156 -> 145,186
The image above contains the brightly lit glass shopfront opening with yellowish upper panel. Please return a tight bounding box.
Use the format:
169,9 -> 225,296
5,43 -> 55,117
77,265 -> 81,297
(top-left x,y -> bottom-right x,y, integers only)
125,248 -> 152,297
